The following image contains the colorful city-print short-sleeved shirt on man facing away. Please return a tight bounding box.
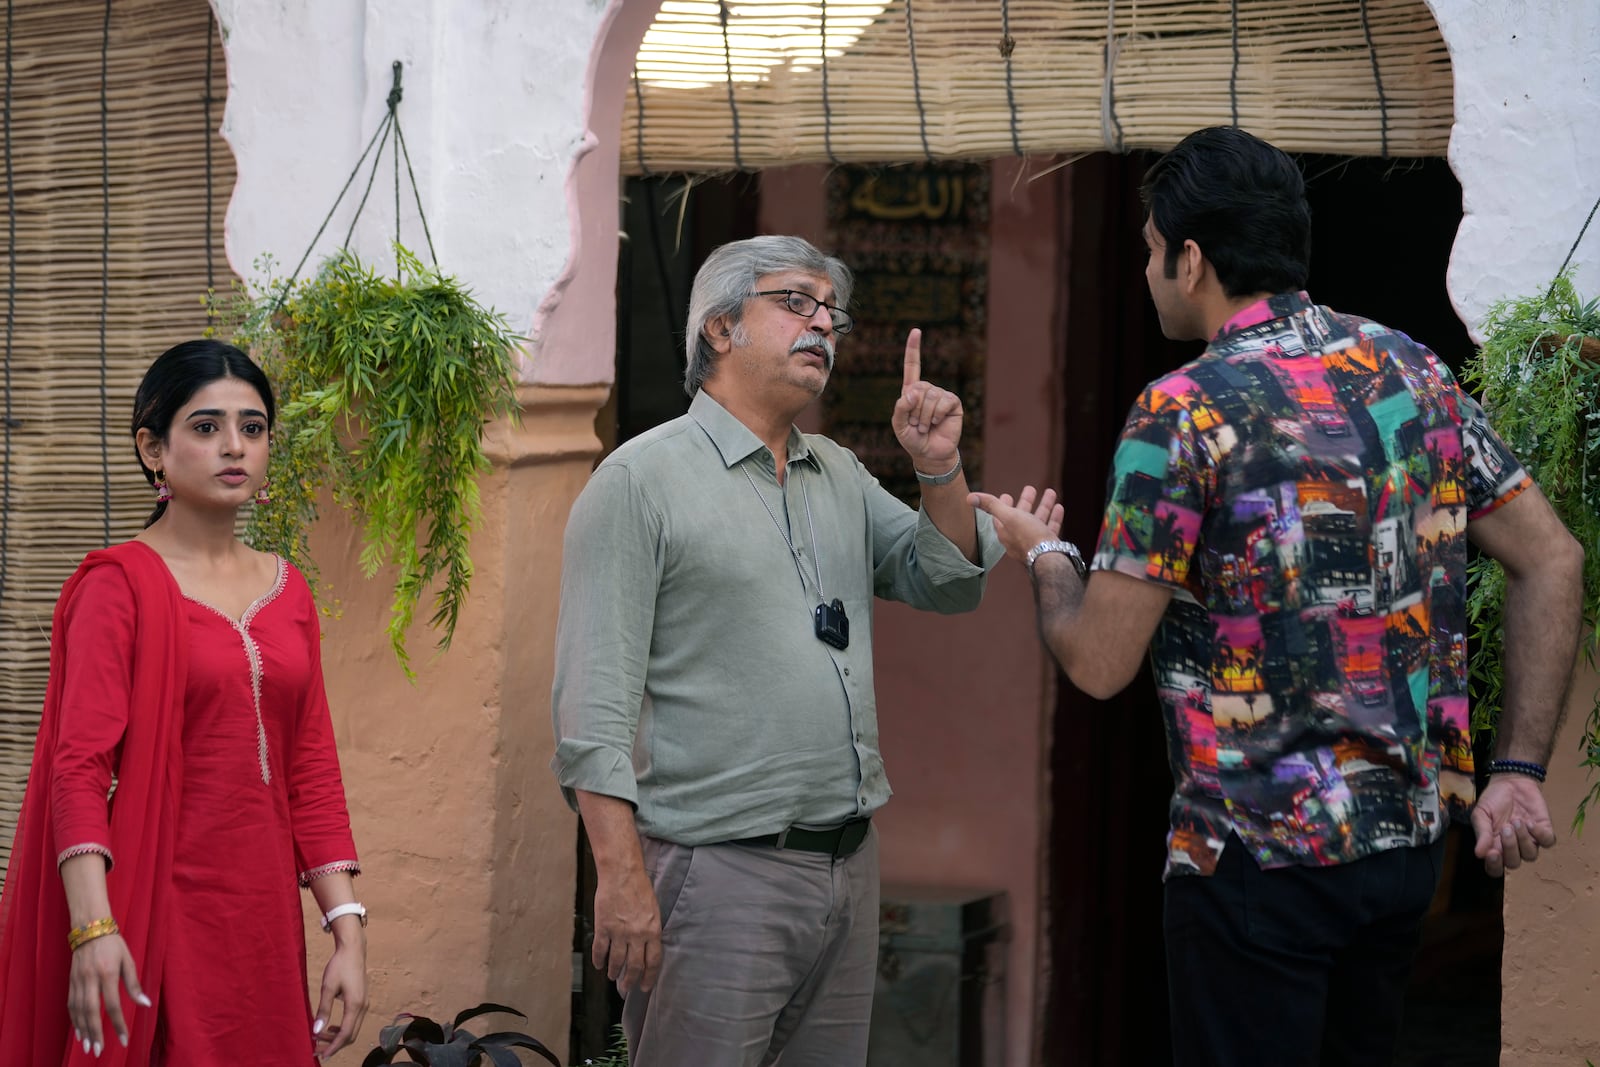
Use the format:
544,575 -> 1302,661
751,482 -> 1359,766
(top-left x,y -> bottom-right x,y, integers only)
1094,293 -> 1531,877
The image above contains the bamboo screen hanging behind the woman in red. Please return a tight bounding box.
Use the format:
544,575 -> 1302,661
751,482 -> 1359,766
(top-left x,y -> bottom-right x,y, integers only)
0,0 -> 234,883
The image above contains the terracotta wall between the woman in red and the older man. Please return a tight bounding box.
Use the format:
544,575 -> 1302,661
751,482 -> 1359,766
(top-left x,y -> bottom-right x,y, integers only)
296,387 -> 606,1051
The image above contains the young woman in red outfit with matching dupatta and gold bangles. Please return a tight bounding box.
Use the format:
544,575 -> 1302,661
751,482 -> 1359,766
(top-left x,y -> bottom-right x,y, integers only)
0,341 -> 366,1067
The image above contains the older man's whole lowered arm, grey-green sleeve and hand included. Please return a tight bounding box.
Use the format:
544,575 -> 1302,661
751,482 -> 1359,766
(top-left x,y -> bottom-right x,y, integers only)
550,466 -> 662,993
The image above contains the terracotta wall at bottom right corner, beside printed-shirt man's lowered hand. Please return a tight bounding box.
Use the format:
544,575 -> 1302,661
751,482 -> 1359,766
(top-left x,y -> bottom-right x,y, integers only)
1501,662 -> 1600,1067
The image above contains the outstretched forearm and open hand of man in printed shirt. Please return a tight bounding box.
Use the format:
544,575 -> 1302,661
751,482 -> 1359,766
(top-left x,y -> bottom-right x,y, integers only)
970,486 -> 1173,701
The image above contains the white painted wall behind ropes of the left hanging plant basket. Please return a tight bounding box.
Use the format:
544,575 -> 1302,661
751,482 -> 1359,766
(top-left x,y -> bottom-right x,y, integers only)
213,0 -> 611,382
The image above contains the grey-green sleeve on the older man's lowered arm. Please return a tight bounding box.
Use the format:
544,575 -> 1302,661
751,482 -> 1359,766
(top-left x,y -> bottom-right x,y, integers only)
550,464 -> 664,806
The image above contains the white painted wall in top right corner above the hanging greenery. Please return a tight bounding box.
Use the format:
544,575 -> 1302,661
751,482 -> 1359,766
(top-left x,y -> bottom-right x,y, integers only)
1429,0 -> 1600,328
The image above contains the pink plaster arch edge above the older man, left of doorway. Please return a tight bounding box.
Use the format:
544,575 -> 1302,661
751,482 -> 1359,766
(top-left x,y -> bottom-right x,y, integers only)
531,0 -> 661,386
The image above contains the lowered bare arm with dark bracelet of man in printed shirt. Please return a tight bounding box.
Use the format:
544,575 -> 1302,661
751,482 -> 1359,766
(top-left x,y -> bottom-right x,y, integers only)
1467,486 -> 1584,877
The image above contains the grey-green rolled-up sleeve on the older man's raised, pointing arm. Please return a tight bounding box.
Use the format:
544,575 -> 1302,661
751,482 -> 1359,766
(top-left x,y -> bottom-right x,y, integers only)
861,467 -> 1005,614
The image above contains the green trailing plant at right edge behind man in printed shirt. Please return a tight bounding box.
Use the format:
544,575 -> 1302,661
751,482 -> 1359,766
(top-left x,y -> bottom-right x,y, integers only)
1462,272 -> 1600,830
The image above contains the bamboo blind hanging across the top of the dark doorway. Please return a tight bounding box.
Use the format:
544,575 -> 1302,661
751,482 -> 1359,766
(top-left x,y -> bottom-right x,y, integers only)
621,0 -> 1454,174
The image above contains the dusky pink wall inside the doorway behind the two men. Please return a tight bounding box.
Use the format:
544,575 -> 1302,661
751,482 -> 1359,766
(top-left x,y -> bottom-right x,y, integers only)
762,162 -> 1062,1067
